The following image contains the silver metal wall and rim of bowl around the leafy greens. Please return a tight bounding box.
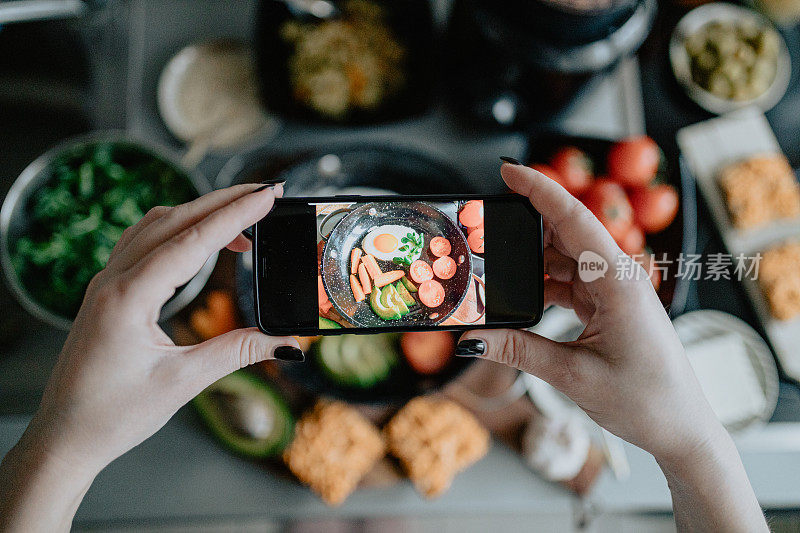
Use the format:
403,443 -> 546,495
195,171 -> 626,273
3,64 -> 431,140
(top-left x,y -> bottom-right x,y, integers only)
0,131 -> 217,330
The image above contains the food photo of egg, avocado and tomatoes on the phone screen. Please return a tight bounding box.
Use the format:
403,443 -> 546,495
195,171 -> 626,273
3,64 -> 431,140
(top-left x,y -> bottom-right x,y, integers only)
314,200 -> 486,328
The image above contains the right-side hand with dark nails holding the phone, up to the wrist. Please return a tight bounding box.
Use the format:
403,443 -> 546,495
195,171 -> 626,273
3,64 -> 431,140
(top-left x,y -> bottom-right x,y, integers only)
457,164 -> 724,461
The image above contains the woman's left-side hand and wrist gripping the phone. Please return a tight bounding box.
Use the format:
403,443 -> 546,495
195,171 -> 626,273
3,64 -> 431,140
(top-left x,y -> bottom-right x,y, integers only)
0,184 -> 302,530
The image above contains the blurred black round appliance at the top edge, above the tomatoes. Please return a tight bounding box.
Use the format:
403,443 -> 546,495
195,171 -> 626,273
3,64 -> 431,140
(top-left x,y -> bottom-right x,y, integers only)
447,0 -> 657,127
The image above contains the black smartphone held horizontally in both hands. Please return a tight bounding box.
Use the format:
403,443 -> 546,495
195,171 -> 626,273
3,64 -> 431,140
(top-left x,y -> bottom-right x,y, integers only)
252,194 -> 544,335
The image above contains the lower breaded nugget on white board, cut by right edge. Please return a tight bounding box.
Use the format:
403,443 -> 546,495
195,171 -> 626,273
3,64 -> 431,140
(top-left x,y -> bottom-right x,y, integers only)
758,242 -> 800,320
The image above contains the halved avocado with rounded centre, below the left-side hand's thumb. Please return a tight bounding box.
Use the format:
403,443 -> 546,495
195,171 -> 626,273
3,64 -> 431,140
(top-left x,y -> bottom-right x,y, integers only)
192,370 -> 294,458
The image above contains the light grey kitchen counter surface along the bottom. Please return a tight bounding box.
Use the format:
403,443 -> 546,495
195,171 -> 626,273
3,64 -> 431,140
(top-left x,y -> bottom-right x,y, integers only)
0,409 -> 800,527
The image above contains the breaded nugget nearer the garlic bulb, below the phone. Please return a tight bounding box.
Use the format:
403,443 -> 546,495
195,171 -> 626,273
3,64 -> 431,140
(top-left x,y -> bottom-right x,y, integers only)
384,396 -> 489,498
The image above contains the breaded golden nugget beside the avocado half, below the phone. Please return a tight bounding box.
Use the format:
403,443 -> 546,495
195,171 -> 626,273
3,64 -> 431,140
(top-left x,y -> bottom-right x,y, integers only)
283,401 -> 386,505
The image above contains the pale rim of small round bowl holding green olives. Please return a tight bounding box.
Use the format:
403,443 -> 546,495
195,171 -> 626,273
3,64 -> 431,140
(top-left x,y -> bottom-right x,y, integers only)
669,2 -> 792,115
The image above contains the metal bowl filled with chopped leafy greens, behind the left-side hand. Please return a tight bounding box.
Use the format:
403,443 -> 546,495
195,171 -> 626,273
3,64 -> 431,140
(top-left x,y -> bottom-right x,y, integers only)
0,132 -> 216,329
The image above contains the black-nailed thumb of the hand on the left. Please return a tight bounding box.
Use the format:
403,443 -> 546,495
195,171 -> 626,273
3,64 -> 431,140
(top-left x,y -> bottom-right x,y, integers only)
189,328 -> 305,381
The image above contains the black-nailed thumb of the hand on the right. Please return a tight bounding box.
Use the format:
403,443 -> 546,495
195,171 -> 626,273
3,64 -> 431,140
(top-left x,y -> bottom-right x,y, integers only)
456,329 -> 578,391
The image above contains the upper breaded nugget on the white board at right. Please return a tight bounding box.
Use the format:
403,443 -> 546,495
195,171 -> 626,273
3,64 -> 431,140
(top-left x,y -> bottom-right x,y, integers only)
719,154 -> 800,229
